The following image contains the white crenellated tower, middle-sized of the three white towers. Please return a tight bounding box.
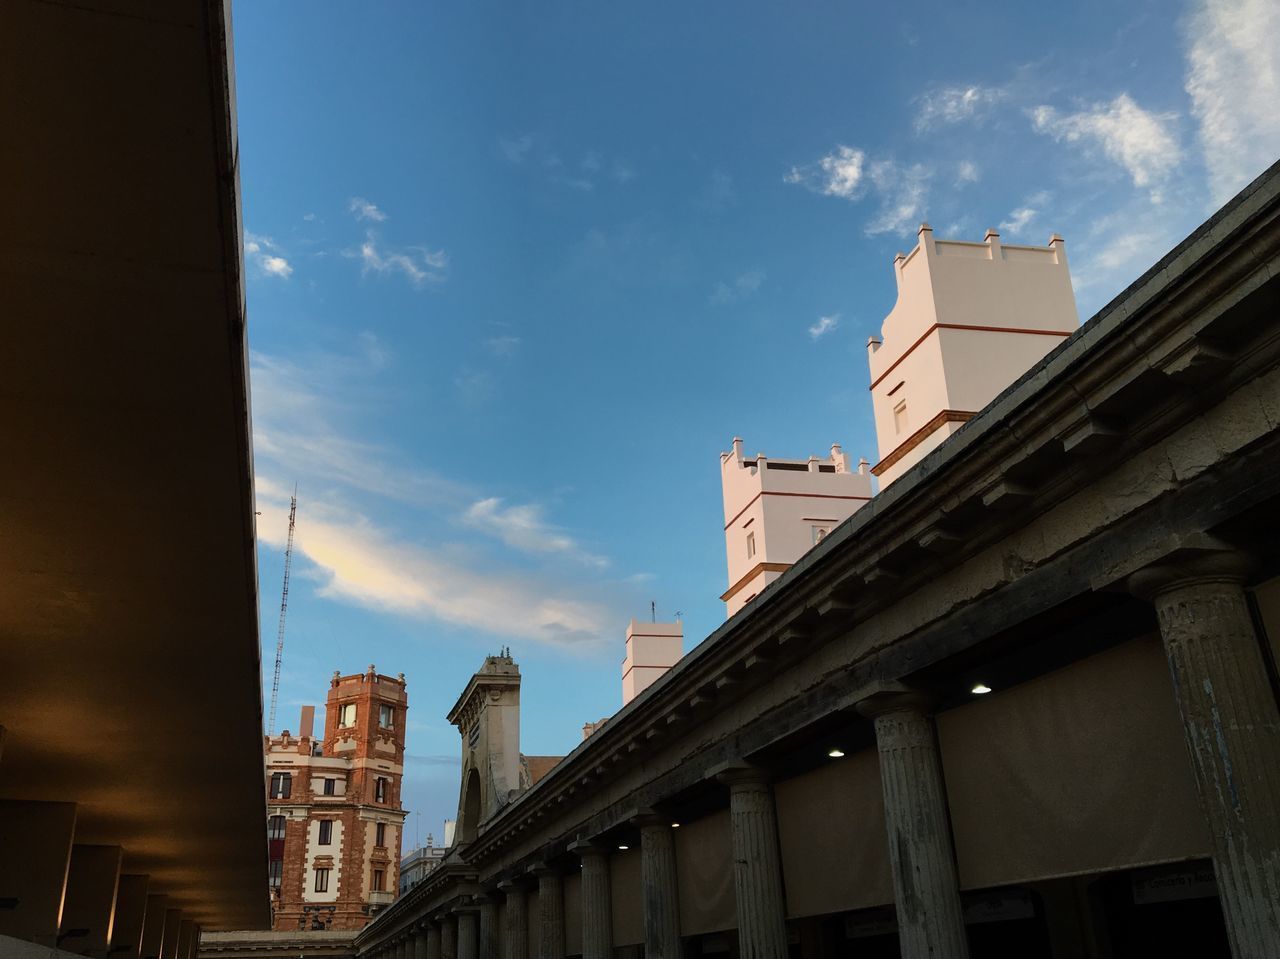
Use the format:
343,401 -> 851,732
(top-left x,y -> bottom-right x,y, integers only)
721,437 -> 872,616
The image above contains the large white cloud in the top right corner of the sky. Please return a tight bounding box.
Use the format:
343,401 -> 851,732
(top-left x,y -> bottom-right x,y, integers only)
1187,0 -> 1280,206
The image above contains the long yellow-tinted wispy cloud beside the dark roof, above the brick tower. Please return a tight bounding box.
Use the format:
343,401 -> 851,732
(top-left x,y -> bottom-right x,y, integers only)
251,337 -> 618,645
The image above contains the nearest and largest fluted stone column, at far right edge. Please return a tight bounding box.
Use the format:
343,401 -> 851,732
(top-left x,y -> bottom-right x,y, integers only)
1130,552 -> 1280,959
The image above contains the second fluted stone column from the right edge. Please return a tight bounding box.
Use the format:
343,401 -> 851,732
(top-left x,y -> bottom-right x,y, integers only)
858,691 -> 969,959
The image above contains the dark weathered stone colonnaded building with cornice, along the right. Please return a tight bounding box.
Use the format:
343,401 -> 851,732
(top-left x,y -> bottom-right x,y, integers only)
356,164 -> 1280,959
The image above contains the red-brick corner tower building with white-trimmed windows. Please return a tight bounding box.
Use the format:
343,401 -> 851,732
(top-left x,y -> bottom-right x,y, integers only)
266,666 -> 408,931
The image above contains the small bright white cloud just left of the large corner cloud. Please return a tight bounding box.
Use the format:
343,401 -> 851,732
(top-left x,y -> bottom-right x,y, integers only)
1032,93 -> 1181,198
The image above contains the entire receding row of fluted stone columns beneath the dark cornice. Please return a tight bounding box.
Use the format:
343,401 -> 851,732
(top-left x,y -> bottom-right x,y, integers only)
363,554 -> 1280,959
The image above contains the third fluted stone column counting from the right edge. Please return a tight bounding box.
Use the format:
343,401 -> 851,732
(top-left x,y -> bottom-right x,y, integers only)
717,766 -> 787,959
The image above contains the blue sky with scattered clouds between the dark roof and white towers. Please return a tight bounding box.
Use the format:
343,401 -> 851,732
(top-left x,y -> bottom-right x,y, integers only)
234,0 -> 1280,848
